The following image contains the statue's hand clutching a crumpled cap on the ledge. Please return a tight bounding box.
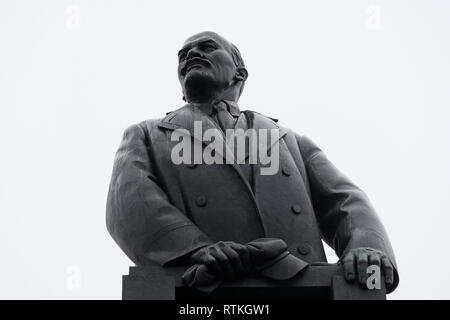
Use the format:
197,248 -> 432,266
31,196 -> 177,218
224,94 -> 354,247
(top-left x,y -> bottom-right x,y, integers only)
190,241 -> 253,280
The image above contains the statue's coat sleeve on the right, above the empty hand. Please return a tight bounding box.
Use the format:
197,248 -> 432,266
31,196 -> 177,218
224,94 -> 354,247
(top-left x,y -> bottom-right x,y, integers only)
297,136 -> 399,292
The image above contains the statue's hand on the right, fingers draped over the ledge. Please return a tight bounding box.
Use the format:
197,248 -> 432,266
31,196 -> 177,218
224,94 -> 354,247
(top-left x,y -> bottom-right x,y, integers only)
339,248 -> 394,285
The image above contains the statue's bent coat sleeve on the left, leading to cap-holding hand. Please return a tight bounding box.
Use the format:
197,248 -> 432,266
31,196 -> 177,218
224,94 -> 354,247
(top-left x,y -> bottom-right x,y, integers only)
106,125 -> 212,266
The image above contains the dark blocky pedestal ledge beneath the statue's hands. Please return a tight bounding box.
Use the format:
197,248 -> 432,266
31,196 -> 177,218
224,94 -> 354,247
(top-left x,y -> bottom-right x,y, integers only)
122,264 -> 386,301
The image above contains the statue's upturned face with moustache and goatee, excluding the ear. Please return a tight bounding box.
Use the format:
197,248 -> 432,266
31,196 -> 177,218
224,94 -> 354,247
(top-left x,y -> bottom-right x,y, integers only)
178,32 -> 236,100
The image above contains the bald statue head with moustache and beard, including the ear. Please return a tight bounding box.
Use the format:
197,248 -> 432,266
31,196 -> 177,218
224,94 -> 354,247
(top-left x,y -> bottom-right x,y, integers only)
178,31 -> 248,102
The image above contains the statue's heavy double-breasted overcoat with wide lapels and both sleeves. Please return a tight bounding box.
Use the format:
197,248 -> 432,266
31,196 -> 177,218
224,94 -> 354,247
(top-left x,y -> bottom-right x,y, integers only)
106,104 -> 398,291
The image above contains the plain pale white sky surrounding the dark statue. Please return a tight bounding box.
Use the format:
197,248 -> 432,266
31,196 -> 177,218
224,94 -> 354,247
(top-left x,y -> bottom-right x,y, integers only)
0,0 -> 450,299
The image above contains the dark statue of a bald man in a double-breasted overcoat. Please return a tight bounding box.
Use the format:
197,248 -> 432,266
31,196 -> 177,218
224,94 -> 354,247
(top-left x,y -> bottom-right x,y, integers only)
106,32 -> 399,292
